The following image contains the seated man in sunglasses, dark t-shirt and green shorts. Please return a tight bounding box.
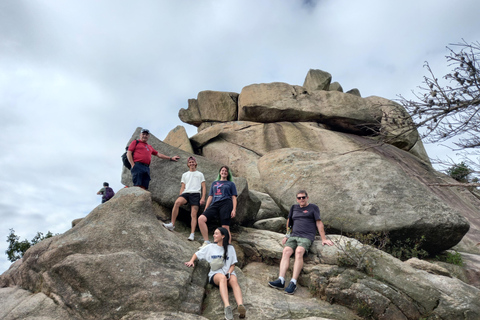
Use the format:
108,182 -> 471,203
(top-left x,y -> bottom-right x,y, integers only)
268,190 -> 333,294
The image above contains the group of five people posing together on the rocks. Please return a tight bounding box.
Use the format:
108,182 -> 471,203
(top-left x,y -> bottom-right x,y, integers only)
122,129 -> 333,320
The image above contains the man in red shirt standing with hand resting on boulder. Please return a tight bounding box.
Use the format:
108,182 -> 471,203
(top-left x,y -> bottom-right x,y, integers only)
127,129 -> 180,190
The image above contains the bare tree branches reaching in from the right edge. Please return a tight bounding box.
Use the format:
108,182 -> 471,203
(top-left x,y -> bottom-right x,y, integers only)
400,40 -> 480,182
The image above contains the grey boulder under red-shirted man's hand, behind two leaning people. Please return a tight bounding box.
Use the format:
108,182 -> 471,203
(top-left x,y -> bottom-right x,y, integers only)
122,128 -> 260,224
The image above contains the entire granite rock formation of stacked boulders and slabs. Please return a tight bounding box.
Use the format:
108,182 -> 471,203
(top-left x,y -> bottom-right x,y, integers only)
0,70 -> 480,320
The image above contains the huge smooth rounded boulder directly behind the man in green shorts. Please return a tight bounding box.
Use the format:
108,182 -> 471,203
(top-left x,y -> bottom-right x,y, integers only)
258,138 -> 470,252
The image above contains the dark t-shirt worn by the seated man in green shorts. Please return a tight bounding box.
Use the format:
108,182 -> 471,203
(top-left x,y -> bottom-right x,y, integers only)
288,203 -> 321,241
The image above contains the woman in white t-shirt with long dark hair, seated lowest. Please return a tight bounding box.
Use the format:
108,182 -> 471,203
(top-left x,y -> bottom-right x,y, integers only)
185,227 -> 246,320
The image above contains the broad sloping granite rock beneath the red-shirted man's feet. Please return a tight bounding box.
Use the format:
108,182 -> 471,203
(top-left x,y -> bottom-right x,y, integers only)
0,188 -> 208,319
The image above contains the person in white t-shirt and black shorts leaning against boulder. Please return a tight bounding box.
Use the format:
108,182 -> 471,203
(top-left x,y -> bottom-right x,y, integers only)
163,157 -> 206,241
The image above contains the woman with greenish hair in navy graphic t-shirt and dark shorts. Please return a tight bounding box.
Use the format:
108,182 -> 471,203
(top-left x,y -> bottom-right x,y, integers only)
198,166 -> 237,248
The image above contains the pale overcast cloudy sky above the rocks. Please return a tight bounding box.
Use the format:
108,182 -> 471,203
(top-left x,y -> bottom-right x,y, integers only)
0,0 -> 480,273
